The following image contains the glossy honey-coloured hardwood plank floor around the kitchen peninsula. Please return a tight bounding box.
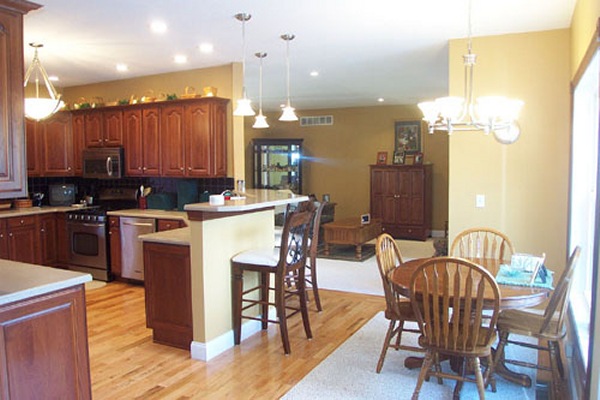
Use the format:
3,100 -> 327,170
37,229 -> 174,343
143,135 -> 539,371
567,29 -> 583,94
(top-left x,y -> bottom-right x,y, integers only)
86,282 -> 385,400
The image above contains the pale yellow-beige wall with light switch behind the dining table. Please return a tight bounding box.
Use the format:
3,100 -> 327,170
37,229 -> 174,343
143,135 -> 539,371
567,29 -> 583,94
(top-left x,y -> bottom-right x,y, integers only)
449,29 -> 570,266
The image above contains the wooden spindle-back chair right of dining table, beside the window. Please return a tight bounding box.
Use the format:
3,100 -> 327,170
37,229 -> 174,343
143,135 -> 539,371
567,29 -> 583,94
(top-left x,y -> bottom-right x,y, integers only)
494,246 -> 581,399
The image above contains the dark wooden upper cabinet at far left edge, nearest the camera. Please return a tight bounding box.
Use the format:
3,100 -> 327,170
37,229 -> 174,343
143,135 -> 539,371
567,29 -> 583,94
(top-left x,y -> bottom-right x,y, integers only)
0,0 -> 40,198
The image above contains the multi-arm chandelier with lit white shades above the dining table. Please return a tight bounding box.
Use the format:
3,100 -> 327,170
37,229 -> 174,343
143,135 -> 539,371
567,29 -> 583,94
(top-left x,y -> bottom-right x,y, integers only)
418,1 -> 524,144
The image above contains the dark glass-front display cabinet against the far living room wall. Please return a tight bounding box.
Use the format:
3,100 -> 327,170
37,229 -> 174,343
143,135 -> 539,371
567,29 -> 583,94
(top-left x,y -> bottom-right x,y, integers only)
252,139 -> 303,193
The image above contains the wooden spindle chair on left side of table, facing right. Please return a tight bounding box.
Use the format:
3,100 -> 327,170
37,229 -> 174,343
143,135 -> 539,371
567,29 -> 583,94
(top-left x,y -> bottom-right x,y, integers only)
375,233 -> 424,373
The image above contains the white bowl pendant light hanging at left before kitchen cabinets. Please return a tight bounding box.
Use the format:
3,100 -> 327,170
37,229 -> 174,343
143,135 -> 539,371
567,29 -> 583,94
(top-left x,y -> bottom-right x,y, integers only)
23,43 -> 64,121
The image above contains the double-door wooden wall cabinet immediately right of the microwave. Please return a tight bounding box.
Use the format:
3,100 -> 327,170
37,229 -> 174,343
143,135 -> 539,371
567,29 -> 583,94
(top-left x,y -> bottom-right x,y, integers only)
123,107 -> 161,176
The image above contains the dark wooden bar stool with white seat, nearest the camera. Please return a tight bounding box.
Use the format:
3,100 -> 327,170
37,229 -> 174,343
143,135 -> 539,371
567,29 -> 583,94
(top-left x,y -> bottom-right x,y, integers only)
231,203 -> 314,354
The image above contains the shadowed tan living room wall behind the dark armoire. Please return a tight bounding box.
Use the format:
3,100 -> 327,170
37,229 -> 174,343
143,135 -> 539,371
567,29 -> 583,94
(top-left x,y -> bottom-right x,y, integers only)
245,105 -> 448,230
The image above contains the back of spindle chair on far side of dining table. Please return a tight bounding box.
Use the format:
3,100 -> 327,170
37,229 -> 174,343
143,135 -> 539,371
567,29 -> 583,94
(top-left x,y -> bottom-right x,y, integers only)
449,228 -> 515,262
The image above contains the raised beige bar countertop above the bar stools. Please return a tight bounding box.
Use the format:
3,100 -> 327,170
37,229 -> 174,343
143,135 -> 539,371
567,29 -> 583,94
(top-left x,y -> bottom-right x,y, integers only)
184,189 -> 308,212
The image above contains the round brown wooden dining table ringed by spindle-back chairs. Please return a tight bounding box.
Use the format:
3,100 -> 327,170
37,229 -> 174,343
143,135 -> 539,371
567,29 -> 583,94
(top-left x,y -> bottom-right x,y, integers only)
389,257 -> 552,387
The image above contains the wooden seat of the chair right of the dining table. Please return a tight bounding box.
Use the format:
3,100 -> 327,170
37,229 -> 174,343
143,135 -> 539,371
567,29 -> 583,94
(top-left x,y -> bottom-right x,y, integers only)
496,309 -> 566,340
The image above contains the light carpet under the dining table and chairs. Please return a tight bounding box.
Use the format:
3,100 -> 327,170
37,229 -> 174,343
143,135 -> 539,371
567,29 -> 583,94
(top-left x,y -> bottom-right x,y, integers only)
282,312 -> 537,400
